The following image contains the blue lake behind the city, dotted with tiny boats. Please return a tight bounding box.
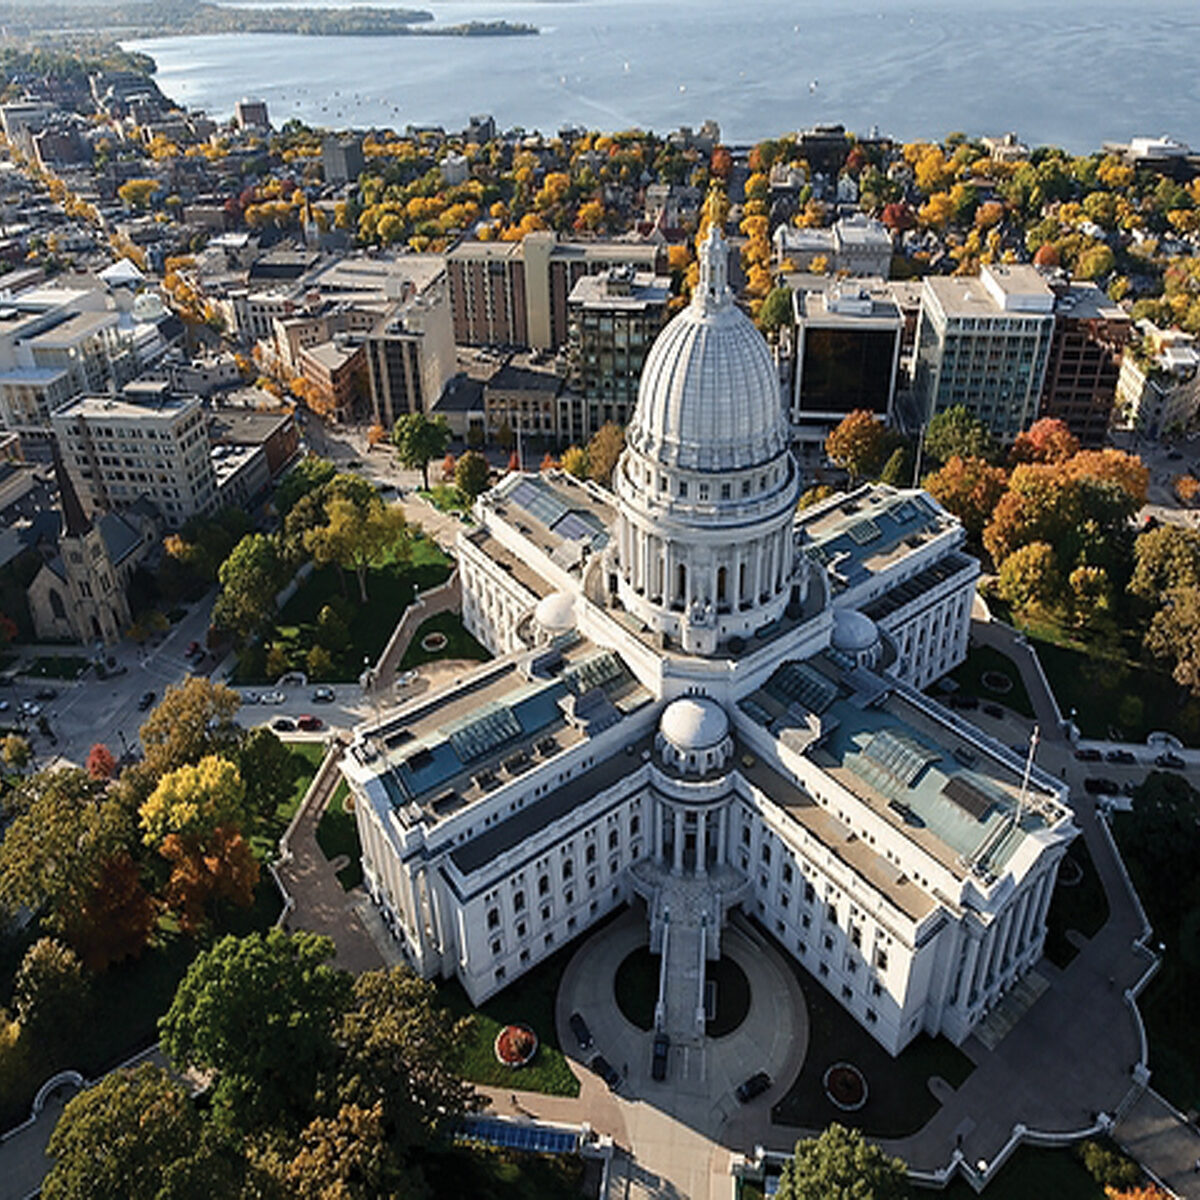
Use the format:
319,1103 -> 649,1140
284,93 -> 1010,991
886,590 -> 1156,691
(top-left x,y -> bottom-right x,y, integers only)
125,0 -> 1200,152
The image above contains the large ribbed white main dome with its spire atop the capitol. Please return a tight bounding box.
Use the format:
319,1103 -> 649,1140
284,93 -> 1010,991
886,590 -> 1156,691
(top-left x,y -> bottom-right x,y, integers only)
625,227 -> 787,470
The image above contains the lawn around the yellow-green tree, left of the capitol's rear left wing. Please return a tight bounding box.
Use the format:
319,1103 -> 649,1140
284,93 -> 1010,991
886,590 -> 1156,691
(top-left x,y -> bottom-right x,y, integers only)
234,536 -> 451,684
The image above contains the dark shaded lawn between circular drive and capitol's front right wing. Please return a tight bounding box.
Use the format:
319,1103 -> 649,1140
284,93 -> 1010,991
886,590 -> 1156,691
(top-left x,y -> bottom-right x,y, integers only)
746,922 -> 974,1138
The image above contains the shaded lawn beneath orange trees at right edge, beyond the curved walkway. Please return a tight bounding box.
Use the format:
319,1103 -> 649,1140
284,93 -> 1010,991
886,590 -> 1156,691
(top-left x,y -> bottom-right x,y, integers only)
1031,637 -> 1200,746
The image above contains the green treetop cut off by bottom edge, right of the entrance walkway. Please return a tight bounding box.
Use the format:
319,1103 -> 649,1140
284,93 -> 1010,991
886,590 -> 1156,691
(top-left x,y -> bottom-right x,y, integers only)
775,1123 -> 908,1200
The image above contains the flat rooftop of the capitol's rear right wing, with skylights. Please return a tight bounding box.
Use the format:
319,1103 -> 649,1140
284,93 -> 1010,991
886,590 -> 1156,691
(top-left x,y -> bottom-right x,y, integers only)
796,484 -> 956,592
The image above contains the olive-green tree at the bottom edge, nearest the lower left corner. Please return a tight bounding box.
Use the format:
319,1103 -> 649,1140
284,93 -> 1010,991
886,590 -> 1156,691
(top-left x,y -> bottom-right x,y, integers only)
42,1063 -> 240,1200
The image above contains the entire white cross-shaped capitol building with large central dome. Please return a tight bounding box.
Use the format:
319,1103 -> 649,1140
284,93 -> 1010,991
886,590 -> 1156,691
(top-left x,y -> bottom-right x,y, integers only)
342,230 -> 1076,1054
